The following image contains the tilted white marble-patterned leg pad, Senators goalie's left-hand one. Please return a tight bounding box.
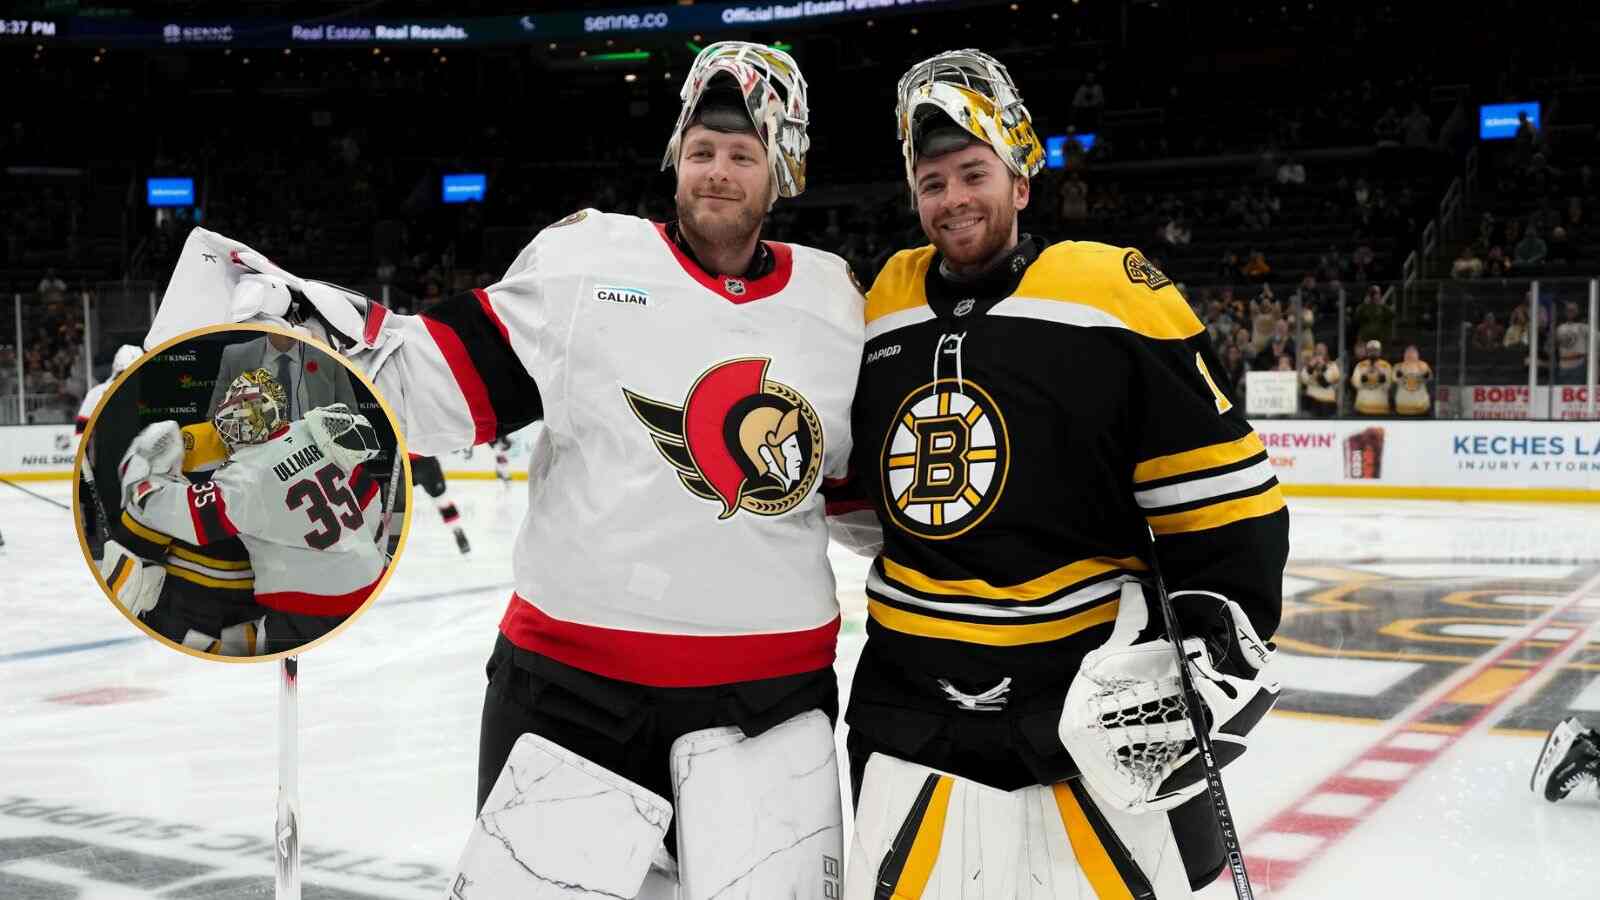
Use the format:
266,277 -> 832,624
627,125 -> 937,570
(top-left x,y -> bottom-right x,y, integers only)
448,733 -> 672,900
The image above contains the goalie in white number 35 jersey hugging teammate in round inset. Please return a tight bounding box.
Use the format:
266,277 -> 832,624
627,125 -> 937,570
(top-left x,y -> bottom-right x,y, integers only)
123,368 -> 387,655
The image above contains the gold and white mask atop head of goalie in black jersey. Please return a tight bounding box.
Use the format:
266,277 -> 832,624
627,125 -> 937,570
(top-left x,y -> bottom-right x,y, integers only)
894,50 -> 1045,192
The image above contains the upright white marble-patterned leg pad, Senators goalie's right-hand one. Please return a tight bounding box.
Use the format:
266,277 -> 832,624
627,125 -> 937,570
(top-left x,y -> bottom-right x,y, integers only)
672,709 -> 845,900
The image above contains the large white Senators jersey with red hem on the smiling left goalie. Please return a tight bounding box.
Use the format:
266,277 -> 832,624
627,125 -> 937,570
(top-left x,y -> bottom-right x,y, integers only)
368,210 -> 864,685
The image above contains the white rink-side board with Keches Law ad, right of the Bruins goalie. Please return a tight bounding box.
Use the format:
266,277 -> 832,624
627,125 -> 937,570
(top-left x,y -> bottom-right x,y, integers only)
1254,420 -> 1600,490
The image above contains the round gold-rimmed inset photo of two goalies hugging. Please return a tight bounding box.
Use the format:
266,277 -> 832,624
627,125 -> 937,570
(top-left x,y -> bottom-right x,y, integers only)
74,325 -> 410,661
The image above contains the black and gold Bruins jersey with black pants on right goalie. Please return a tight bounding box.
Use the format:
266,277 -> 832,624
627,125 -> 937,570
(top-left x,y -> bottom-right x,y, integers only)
846,239 -> 1288,788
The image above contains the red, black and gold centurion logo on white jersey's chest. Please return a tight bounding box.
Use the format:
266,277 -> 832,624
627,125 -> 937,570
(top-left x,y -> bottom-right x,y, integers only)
622,357 -> 822,519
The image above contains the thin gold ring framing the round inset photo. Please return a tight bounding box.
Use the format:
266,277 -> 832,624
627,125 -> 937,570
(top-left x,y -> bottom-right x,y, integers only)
72,322 -> 413,665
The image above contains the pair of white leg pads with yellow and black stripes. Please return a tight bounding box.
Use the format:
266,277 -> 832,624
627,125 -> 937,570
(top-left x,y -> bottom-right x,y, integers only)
845,753 -> 1190,900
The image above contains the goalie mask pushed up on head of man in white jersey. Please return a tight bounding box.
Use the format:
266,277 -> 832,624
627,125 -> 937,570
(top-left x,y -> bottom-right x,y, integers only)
661,40 -> 811,202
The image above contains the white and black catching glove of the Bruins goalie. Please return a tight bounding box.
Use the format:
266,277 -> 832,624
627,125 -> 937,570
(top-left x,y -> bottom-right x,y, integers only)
1059,583 -> 1280,814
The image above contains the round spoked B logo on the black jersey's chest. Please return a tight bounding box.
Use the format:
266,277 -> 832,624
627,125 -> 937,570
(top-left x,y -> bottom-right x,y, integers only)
880,378 -> 1011,540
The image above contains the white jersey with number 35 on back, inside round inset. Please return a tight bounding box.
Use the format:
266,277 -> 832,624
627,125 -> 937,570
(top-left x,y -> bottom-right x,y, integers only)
126,421 -> 386,617
